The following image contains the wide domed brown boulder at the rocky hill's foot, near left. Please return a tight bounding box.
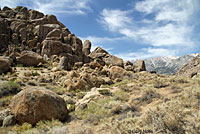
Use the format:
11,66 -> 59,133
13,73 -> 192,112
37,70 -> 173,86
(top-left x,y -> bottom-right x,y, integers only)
17,51 -> 45,66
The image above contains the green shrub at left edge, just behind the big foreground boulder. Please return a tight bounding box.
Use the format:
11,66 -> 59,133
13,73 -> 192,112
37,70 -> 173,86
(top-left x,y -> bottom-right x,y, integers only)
0,81 -> 21,97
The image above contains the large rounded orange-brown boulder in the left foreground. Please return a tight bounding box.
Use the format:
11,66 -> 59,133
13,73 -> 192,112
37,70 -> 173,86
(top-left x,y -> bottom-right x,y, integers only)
10,89 -> 68,125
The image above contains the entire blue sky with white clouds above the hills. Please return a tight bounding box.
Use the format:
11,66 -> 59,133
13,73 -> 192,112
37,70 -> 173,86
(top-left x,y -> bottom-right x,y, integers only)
0,0 -> 200,60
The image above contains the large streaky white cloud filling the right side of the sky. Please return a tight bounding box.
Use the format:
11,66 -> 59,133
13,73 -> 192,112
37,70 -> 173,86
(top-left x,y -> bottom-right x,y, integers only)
98,0 -> 200,59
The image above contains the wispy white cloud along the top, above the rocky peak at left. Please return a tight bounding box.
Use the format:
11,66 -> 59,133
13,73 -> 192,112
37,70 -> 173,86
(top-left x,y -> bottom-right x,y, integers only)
1,0 -> 92,15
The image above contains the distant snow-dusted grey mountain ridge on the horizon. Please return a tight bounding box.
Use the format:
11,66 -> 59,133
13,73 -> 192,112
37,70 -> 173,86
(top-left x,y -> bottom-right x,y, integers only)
132,54 -> 197,75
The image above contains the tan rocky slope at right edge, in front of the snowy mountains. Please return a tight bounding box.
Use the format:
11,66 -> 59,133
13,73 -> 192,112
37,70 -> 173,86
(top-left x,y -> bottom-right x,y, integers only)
176,54 -> 200,77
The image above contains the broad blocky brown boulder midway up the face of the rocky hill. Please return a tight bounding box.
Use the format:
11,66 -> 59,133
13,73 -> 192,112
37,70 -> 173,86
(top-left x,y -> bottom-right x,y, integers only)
41,40 -> 72,57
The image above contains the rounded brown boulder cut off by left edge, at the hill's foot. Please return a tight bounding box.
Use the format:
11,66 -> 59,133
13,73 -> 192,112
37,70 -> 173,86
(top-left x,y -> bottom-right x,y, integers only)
0,56 -> 12,74
